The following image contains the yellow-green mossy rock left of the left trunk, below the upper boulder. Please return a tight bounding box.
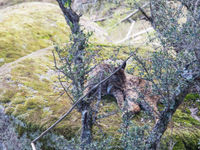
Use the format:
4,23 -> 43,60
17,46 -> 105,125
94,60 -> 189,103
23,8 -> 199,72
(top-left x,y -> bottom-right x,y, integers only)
0,42 -> 133,138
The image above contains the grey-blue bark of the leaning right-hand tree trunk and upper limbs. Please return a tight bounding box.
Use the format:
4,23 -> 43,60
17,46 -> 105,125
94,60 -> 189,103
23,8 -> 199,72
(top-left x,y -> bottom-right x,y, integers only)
143,0 -> 200,150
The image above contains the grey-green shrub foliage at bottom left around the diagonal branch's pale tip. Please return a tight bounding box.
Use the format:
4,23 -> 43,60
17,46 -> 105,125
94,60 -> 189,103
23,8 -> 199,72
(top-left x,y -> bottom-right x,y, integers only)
9,115 -> 74,150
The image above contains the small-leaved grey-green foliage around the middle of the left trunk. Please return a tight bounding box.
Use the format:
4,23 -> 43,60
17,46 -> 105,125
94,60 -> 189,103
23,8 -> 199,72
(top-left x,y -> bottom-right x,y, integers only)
54,31 -> 95,100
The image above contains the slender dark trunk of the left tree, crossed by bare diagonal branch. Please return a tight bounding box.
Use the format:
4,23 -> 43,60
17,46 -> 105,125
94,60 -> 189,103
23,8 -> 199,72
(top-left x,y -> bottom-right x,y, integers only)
57,0 -> 93,146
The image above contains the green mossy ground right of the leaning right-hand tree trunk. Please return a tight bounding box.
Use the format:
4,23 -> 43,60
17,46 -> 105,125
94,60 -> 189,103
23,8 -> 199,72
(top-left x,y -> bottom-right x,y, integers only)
159,93 -> 200,150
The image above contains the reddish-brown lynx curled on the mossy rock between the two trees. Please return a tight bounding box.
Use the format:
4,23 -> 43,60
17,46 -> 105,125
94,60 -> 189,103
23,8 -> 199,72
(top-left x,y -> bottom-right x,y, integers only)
85,64 -> 159,118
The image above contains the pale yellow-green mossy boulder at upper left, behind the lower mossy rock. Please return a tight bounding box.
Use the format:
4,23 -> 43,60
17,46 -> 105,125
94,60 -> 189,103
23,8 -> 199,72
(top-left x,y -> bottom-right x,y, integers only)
0,3 -> 70,65
